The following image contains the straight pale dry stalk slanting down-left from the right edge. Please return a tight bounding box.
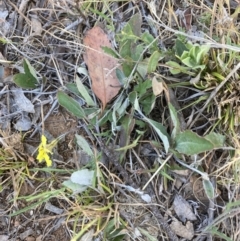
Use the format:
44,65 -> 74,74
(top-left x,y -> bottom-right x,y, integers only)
189,63 -> 240,129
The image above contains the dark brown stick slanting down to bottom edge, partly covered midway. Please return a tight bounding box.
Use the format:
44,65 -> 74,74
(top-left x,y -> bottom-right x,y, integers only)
97,141 -> 179,241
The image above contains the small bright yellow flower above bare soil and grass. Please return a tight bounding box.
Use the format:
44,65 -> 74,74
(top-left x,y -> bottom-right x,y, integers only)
37,135 -> 54,167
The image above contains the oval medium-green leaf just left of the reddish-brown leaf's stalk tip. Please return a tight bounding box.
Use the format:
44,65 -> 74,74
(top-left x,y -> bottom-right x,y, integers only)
57,91 -> 85,118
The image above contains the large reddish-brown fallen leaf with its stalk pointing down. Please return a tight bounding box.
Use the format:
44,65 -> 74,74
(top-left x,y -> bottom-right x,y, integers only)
83,27 -> 121,109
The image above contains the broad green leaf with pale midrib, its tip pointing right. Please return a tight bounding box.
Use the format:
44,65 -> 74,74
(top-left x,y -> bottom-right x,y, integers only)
175,130 -> 214,155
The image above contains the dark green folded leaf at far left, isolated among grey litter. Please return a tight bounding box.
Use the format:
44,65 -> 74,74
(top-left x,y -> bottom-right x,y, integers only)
13,60 -> 38,89
